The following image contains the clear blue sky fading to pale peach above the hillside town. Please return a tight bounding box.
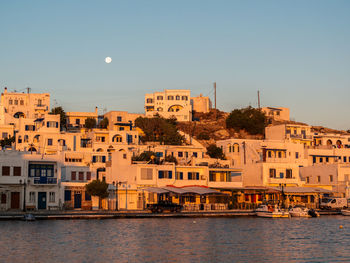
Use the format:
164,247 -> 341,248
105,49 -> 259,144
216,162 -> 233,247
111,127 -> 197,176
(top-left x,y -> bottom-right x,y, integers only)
0,0 -> 350,130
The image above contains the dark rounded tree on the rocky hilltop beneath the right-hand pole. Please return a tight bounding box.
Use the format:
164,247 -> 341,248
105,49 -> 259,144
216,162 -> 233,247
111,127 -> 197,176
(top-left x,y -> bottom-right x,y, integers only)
226,106 -> 267,135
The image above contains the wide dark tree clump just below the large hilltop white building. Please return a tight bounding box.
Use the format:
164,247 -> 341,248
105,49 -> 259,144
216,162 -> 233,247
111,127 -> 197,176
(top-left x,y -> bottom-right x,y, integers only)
135,115 -> 185,145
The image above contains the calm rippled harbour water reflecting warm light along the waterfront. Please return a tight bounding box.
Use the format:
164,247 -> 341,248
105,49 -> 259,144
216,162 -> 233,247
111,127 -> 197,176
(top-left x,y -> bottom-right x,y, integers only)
0,216 -> 350,262
